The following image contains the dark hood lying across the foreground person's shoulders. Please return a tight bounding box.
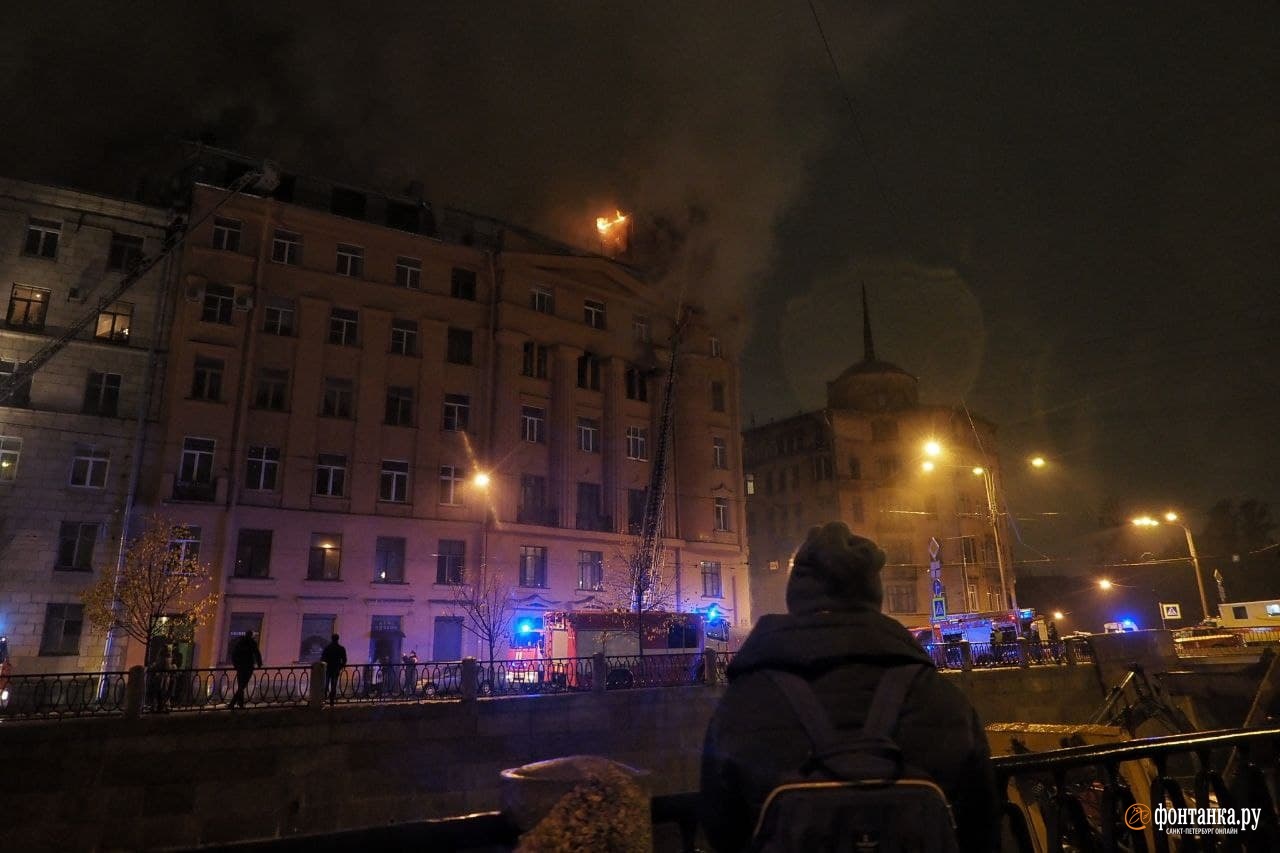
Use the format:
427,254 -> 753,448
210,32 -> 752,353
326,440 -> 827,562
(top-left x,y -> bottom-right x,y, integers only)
728,607 -> 933,679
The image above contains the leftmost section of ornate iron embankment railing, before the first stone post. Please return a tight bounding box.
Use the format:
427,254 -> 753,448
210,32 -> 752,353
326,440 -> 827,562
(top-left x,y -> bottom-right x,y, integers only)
0,672 -> 129,720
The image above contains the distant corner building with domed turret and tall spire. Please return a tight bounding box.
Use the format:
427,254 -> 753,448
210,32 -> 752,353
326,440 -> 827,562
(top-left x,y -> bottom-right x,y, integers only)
742,292 -> 1014,626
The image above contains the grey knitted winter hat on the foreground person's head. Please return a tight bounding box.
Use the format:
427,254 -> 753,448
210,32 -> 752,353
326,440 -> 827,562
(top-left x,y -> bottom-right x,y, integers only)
787,521 -> 884,613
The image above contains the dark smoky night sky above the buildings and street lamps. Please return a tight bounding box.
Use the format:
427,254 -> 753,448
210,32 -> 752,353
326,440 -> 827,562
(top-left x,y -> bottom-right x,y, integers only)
0,6 -> 1280,566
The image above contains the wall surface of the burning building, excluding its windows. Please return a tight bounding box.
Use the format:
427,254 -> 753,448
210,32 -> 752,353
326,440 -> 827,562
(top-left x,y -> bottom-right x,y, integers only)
151,184 -> 749,663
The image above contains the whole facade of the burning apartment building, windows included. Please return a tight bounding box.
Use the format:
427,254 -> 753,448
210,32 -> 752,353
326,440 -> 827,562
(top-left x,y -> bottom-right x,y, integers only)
147,157 -> 750,665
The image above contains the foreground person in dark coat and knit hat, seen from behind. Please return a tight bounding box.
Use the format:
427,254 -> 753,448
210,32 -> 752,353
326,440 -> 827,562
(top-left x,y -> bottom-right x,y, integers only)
700,521 -> 1000,852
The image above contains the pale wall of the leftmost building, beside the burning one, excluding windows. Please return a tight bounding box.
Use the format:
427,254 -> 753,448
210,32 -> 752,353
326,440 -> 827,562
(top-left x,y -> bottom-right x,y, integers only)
0,179 -> 170,672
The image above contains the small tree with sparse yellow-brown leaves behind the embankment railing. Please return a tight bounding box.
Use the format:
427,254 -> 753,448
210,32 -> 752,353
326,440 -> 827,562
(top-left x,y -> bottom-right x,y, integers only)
82,516 -> 218,662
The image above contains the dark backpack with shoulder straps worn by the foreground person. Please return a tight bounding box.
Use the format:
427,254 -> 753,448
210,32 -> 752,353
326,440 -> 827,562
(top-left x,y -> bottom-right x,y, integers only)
751,663 -> 960,853
